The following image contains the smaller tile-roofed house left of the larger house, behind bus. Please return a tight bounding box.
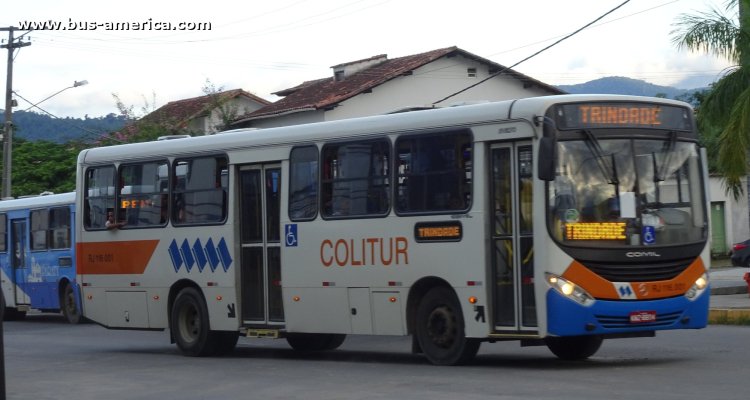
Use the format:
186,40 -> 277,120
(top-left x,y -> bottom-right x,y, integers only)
139,89 -> 270,135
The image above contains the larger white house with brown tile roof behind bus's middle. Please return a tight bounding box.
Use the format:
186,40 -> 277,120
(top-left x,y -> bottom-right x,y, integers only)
231,47 -> 565,128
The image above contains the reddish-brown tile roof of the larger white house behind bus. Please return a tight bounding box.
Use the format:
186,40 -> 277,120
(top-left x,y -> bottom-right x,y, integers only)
235,46 -> 564,123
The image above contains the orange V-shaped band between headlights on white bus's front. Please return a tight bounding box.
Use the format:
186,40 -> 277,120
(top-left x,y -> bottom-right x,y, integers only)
563,258 -> 706,300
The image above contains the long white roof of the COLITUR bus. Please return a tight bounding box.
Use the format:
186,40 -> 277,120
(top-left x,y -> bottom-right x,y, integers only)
78,95 -> 689,165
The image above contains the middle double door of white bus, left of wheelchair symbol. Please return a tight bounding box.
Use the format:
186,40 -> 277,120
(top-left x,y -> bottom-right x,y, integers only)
238,164 -> 284,327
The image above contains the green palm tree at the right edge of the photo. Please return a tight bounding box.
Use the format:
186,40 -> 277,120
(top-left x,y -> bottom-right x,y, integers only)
672,0 -> 750,198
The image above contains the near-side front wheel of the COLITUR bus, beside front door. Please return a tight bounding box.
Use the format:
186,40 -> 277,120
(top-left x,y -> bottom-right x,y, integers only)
415,287 -> 480,365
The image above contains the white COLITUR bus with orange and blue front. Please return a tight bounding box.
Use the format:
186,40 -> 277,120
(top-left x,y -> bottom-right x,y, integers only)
77,95 -> 709,364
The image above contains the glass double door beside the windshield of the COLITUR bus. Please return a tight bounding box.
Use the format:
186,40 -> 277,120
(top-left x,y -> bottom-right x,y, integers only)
488,143 -> 537,334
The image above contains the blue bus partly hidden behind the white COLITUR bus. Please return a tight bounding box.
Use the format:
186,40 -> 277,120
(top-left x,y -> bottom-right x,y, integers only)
0,192 -> 81,324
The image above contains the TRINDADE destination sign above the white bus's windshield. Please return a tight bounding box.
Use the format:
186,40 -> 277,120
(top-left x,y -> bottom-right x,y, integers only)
554,102 -> 691,131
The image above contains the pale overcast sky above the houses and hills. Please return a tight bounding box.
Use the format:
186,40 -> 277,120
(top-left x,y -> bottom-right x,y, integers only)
0,0 -> 731,118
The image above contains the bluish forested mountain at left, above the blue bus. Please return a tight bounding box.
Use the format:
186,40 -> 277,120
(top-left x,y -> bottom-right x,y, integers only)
0,111 -> 127,143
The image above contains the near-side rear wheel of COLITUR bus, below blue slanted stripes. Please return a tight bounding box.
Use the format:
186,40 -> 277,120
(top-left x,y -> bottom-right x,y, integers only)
170,287 -> 217,357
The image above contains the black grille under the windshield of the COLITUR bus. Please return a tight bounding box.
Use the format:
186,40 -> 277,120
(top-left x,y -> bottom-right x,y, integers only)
582,258 -> 694,282
